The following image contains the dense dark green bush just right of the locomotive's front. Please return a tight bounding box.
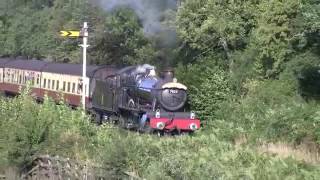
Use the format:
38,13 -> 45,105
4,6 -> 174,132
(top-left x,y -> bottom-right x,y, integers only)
177,56 -> 232,121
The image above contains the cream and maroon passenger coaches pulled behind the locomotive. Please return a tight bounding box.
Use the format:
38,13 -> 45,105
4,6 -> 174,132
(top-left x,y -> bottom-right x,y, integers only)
0,59 -> 115,107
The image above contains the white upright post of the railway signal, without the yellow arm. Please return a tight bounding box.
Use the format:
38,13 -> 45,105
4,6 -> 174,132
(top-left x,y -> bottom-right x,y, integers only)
80,22 -> 89,109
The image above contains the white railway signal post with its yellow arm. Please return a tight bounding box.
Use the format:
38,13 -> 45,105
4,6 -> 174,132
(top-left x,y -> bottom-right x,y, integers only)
60,22 -> 90,109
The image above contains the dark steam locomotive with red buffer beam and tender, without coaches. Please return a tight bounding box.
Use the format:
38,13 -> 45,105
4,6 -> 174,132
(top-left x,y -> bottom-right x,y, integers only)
92,65 -> 200,133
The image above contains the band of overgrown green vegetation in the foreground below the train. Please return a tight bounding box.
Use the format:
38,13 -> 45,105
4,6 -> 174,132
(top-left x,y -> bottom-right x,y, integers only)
0,91 -> 320,179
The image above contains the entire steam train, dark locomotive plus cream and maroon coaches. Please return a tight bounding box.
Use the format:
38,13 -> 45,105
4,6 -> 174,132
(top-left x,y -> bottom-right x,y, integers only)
0,58 -> 200,133
